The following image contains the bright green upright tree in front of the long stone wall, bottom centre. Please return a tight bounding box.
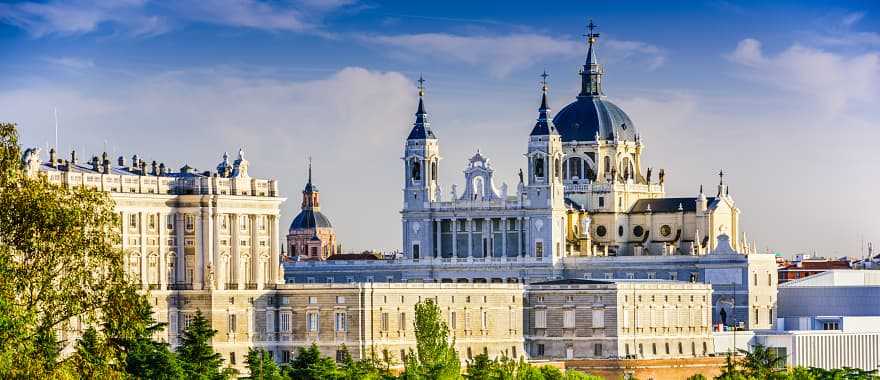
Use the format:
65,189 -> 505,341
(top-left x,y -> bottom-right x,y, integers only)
404,298 -> 461,379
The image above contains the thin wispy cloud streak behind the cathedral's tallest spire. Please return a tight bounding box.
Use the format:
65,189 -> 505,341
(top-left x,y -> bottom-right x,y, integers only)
362,33 -> 665,77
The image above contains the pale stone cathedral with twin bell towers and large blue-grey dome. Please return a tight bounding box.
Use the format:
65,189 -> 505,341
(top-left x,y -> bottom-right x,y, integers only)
403,23 -> 748,261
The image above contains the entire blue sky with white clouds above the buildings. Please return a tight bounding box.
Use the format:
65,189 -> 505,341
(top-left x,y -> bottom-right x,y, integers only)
0,0 -> 880,257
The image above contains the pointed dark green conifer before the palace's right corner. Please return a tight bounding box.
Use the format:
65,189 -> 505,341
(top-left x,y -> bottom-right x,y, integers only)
177,310 -> 229,379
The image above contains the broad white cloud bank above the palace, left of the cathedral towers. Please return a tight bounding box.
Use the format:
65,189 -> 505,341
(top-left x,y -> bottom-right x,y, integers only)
0,68 -> 416,249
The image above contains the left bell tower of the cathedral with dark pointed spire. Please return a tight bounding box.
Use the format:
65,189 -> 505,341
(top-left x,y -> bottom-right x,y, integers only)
403,77 -> 440,211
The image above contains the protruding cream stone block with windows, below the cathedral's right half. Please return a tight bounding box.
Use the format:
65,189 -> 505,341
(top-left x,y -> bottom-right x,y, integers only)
526,280 -> 714,360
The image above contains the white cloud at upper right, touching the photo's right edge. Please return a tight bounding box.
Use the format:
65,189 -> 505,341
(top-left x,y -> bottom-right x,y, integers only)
727,38 -> 880,116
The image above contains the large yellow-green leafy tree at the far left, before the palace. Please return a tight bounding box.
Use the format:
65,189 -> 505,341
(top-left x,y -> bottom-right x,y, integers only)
0,123 -> 146,378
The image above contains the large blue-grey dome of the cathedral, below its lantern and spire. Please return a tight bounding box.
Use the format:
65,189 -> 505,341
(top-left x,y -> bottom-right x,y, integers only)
553,96 -> 636,141
